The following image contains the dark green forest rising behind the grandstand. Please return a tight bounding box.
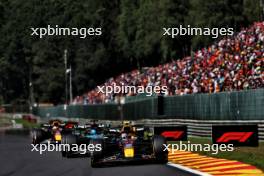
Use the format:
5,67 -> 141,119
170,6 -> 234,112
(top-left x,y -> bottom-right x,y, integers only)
0,0 -> 262,104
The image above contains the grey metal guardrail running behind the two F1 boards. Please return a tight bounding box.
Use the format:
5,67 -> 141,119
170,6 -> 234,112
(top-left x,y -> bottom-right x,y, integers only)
136,119 -> 264,141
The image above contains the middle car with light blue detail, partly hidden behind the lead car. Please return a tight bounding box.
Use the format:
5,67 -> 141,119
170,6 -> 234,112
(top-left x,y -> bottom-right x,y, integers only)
61,124 -> 104,158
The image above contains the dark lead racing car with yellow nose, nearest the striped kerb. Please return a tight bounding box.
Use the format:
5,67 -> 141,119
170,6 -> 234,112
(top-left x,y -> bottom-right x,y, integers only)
88,125 -> 168,167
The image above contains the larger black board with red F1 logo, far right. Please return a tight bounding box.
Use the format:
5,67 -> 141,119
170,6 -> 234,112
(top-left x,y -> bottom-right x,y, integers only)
212,125 -> 258,146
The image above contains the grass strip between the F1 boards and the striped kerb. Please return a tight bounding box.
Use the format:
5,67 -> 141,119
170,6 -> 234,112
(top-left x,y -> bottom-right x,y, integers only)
171,138 -> 264,171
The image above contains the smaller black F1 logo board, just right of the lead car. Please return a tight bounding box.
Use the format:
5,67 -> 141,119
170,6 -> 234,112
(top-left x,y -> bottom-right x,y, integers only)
154,126 -> 187,141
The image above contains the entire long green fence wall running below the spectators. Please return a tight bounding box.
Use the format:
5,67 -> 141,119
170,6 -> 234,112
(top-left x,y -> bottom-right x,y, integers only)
34,89 -> 264,121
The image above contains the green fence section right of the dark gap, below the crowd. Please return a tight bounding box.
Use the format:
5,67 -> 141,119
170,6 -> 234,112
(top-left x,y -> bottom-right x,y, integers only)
163,89 -> 264,120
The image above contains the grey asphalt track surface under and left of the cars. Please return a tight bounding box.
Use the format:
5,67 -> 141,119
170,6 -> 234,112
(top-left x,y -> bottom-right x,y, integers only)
0,134 -> 196,176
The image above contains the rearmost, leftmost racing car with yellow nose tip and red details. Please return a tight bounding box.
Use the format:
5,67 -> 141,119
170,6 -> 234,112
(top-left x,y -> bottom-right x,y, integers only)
31,120 -> 78,144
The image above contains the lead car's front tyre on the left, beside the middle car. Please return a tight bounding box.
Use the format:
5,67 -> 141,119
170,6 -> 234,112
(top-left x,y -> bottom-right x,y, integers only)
90,139 -> 104,168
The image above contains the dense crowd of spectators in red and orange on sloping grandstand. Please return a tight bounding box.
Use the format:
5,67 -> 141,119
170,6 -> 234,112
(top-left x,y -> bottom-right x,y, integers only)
74,22 -> 264,104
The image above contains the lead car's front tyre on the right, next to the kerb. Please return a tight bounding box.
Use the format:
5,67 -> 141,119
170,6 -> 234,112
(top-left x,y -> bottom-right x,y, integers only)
153,135 -> 168,164
